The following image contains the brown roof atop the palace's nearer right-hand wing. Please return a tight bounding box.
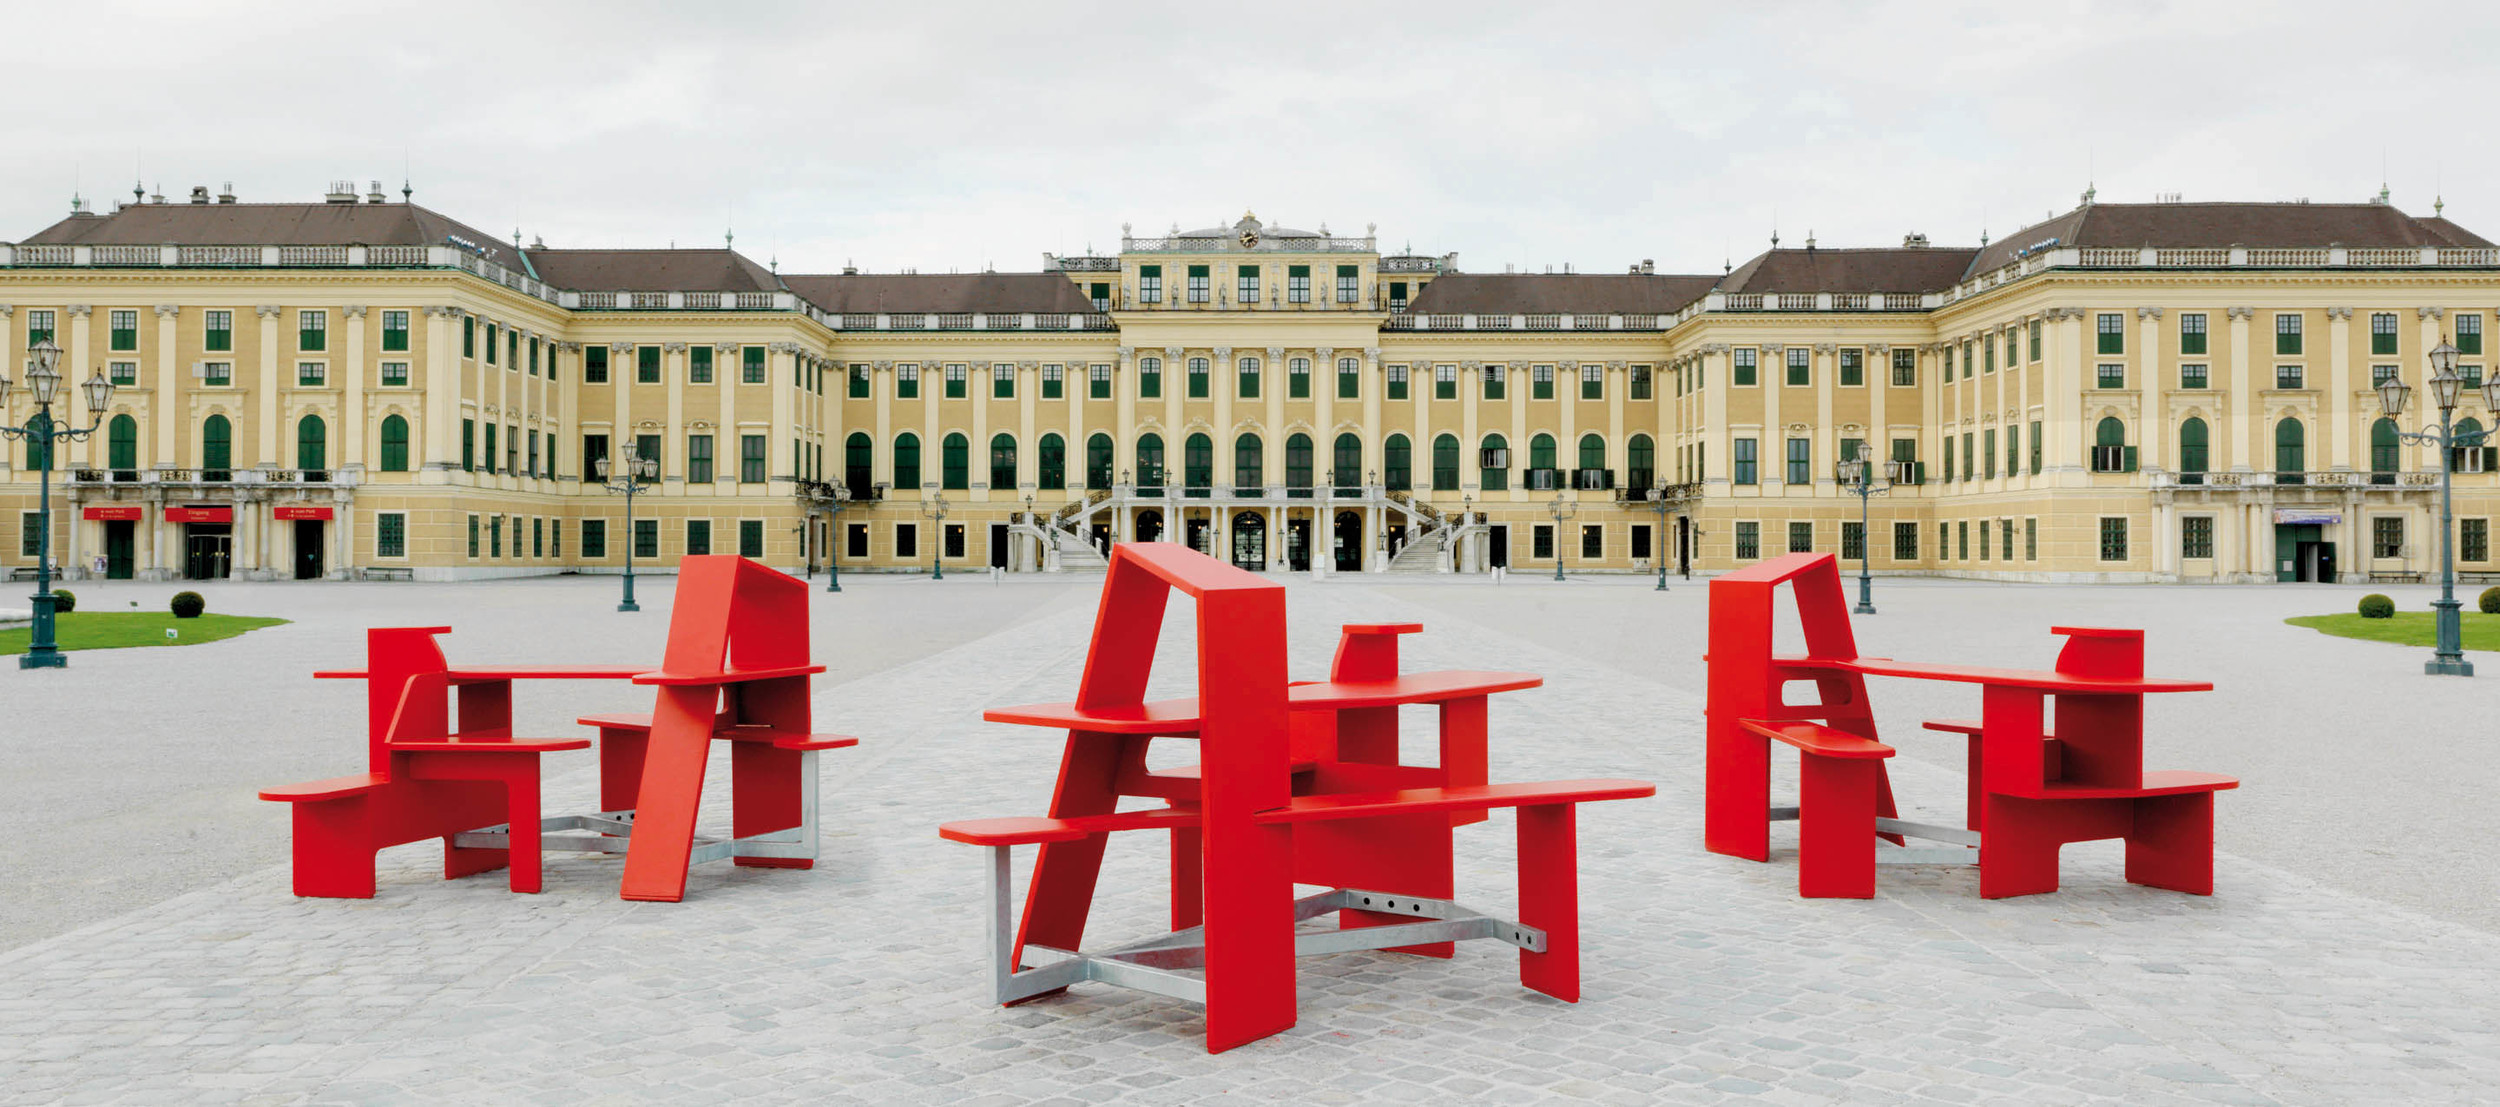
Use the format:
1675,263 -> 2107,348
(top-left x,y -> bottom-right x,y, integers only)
1970,202 -> 2493,272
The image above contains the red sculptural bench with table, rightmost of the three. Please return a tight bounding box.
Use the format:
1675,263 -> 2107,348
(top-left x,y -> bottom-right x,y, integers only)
1705,555 -> 2240,900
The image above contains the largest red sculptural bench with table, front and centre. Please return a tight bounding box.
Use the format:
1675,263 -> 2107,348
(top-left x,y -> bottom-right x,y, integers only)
940,542 -> 1655,1052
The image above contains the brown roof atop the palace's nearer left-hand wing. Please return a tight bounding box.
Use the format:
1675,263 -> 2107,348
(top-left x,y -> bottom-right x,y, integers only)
25,202 -> 528,272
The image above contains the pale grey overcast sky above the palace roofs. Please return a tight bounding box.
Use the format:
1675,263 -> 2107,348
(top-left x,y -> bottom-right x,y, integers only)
0,0 -> 2500,272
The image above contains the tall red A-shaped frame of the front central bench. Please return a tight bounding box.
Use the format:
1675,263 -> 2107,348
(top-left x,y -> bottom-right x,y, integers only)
1013,542 -> 1295,1050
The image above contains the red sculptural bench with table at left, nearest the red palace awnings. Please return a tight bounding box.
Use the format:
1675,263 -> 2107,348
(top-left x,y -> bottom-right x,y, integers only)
260,557 -> 858,900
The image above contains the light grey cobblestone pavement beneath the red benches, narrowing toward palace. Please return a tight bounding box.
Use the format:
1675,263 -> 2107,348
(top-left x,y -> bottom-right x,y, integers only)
0,585 -> 2500,1105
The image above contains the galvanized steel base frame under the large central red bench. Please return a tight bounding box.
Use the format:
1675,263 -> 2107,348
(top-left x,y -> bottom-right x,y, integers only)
988,845 -> 1545,1005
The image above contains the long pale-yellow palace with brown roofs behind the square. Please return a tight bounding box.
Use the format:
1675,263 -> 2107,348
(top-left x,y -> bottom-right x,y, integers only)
0,182 -> 2500,582
